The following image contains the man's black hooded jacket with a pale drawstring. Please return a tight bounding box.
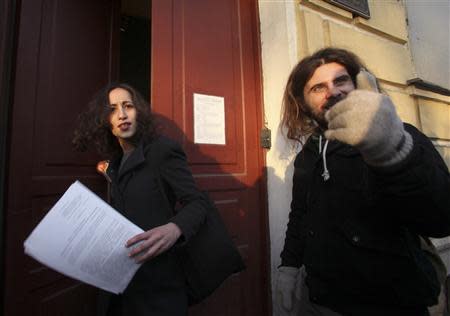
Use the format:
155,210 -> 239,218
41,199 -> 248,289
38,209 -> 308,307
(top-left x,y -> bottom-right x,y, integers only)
281,124 -> 450,316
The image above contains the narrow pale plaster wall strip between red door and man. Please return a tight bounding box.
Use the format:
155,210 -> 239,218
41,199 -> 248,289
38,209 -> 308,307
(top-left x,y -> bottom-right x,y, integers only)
259,1 -> 298,315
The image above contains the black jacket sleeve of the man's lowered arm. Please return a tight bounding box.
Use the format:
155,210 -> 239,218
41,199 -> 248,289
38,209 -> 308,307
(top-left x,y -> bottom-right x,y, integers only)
281,154 -> 306,267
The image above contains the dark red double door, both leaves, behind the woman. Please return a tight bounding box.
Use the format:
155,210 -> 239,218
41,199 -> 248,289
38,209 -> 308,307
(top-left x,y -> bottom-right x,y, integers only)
3,0 -> 270,316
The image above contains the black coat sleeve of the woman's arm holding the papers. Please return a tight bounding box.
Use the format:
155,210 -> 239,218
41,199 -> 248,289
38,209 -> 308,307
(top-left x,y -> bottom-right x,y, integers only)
159,142 -> 207,241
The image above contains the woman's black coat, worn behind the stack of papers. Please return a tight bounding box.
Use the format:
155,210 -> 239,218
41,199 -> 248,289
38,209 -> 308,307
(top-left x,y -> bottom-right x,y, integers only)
100,136 -> 206,316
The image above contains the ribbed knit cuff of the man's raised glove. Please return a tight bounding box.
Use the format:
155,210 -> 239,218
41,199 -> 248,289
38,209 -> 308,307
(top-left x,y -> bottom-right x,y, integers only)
364,131 -> 414,167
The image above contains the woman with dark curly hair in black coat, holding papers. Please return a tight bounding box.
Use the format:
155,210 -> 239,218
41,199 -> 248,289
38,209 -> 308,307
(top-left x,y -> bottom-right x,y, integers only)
73,83 -> 207,316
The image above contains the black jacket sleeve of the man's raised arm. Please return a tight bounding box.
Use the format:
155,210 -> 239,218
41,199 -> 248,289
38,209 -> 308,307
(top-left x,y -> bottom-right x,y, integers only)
372,124 -> 450,238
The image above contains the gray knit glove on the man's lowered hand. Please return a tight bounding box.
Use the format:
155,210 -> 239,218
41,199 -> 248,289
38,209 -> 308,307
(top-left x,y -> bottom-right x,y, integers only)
275,266 -> 299,312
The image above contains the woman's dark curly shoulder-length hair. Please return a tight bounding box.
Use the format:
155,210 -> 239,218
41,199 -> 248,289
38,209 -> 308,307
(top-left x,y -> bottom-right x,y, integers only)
72,82 -> 155,159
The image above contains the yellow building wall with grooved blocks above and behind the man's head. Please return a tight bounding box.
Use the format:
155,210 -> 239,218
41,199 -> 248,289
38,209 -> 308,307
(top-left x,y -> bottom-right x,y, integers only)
296,0 -> 450,167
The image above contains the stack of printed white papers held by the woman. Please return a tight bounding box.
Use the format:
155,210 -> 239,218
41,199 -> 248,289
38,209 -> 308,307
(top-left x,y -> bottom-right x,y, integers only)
24,181 -> 142,294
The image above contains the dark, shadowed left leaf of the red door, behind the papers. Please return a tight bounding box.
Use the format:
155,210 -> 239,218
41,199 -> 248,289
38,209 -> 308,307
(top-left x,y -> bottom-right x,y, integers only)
2,0 -> 118,316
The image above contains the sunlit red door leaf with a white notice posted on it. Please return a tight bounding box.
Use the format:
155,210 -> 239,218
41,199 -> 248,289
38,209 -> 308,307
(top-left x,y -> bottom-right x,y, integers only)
151,0 -> 270,316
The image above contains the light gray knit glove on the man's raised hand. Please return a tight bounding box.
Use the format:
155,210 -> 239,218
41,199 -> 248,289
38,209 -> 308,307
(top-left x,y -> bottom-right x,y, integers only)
325,72 -> 413,166
